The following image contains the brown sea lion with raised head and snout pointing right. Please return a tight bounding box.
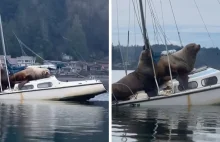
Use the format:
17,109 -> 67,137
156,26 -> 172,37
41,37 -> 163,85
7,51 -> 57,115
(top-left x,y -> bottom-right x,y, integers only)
157,43 -> 200,89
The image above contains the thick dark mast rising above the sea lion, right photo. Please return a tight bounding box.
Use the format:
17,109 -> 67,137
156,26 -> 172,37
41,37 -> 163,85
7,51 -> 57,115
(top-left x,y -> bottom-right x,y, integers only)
139,0 -> 150,49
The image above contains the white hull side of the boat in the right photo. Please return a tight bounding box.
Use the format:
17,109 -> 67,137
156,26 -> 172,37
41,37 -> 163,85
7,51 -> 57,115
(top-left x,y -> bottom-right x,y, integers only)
114,85 -> 220,107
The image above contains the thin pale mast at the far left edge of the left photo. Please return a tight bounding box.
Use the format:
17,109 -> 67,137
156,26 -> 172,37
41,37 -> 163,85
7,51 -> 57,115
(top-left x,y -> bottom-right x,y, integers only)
0,15 -> 11,90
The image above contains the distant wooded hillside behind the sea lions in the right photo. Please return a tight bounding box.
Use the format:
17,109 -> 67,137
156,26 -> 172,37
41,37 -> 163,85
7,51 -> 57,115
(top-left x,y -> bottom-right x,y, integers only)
112,45 -> 220,70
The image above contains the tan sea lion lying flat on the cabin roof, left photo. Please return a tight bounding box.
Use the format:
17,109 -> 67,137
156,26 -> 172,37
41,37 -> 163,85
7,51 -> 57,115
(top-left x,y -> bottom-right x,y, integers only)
10,67 -> 50,89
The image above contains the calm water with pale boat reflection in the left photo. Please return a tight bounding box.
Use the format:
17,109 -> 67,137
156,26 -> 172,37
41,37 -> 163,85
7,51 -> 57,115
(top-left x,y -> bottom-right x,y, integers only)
0,101 -> 108,142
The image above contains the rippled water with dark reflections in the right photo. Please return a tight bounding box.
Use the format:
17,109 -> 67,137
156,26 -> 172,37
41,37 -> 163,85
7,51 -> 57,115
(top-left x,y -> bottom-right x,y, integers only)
112,106 -> 220,142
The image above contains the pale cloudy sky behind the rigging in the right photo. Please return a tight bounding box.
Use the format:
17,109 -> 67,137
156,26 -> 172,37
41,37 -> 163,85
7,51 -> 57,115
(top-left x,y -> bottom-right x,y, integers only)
112,0 -> 220,48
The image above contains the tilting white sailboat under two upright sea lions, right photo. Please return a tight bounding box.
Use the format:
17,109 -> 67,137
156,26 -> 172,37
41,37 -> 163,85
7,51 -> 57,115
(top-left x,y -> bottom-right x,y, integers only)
112,0 -> 220,107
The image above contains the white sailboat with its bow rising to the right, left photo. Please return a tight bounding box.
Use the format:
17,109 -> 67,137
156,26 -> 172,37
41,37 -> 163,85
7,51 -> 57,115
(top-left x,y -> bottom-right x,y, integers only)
0,15 -> 106,101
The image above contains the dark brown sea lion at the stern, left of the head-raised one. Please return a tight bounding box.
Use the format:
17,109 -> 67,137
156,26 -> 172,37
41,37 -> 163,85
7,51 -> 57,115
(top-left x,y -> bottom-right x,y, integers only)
112,50 -> 156,100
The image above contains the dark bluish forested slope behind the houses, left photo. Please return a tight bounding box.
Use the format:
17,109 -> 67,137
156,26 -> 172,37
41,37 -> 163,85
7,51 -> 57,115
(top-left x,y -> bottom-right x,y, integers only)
0,0 -> 109,61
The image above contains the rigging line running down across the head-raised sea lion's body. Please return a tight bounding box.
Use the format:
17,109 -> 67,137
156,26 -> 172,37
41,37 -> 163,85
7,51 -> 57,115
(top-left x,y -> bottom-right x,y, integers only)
160,0 -> 174,93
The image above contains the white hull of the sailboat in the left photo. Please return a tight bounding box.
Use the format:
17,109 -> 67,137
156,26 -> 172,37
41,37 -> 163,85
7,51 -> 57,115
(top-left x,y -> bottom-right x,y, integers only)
0,83 -> 106,101
